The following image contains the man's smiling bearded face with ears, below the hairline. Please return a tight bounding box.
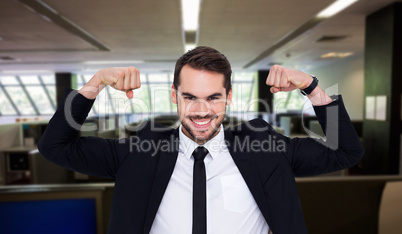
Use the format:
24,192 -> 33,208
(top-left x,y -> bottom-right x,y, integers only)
172,65 -> 232,144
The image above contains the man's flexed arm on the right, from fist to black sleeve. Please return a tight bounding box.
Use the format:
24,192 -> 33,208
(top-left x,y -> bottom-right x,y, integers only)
267,66 -> 364,176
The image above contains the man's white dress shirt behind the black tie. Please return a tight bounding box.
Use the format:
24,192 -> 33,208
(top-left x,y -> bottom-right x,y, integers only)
150,126 -> 268,234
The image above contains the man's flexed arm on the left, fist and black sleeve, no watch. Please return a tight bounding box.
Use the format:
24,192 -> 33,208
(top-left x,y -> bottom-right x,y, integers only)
38,67 -> 140,178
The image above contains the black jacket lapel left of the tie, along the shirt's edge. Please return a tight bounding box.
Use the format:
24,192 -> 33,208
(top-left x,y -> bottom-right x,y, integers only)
144,128 -> 179,233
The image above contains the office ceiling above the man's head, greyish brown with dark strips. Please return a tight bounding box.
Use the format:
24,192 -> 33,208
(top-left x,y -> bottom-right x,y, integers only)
0,0 -> 394,74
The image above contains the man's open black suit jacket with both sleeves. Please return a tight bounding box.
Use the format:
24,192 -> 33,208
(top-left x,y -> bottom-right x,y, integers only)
38,91 -> 363,234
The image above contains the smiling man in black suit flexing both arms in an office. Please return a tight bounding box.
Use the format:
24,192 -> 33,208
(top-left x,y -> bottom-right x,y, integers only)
38,47 -> 363,234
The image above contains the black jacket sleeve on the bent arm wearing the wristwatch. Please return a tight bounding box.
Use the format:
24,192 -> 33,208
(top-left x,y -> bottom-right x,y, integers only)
286,95 -> 364,176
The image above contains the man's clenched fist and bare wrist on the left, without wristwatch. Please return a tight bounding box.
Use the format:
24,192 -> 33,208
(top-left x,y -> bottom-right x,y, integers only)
78,67 -> 141,99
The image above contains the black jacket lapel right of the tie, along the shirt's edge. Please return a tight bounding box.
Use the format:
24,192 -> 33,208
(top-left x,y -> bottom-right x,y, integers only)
225,130 -> 271,226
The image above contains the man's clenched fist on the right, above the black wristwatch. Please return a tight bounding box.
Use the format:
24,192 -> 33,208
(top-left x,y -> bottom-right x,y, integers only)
266,65 -> 313,93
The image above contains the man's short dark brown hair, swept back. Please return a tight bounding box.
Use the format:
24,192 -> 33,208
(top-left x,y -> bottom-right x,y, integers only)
173,46 -> 232,94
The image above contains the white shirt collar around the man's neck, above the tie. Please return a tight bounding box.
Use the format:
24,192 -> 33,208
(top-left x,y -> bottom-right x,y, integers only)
179,125 -> 227,160
